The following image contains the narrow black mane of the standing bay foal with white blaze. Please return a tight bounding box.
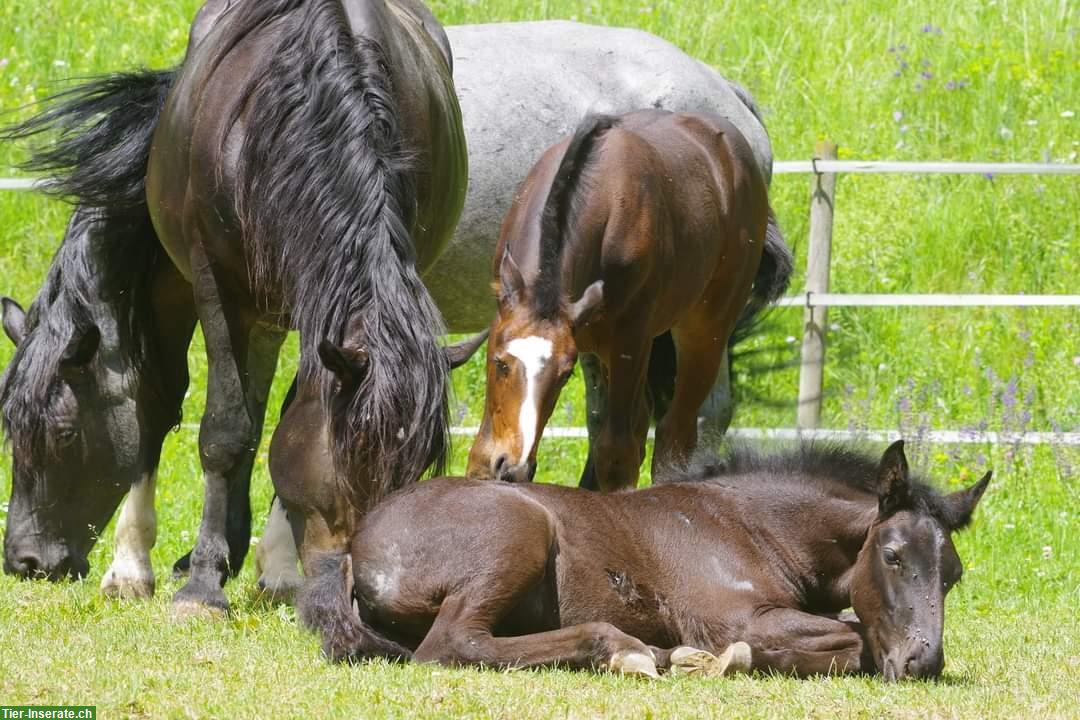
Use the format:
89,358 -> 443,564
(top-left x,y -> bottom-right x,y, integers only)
530,116 -> 618,318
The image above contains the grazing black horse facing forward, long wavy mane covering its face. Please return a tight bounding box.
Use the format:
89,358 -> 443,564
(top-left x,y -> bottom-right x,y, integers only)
146,0 -> 465,609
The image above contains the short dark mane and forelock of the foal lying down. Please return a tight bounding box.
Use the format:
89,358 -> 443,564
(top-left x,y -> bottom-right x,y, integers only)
661,443 -> 956,528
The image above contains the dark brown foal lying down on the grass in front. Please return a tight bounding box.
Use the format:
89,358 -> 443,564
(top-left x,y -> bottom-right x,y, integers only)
300,441 -> 990,679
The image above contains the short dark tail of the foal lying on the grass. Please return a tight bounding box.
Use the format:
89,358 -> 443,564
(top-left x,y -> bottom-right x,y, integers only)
296,553 -> 413,662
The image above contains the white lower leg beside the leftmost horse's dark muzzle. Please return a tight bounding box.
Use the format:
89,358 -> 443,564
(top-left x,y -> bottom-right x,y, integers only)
102,474 -> 158,598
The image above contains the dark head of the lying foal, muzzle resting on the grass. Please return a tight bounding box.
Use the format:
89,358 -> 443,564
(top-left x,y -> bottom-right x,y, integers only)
851,440 -> 990,680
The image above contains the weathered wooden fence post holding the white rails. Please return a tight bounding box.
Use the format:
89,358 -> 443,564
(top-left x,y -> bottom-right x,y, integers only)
797,140 -> 837,430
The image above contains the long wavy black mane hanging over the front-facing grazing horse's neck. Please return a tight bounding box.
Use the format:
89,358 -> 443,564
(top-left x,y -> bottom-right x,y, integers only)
221,0 -> 449,507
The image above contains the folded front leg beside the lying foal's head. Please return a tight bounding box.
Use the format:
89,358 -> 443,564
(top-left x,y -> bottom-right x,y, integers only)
744,608 -> 877,677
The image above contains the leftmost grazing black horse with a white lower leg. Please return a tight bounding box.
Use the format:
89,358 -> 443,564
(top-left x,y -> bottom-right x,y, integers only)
0,71 -> 194,597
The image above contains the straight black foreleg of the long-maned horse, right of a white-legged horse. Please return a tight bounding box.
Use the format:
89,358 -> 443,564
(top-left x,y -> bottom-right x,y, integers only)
173,263 -> 284,613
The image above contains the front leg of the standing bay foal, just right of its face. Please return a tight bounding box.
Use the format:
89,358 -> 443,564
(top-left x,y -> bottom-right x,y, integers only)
591,337 -> 650,492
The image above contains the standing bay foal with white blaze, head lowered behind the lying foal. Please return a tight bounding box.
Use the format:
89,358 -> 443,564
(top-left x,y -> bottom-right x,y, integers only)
469,110 -> 787,490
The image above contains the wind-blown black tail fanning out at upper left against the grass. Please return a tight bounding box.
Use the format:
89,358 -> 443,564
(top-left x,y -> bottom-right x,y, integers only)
0,70 -> 176,212
